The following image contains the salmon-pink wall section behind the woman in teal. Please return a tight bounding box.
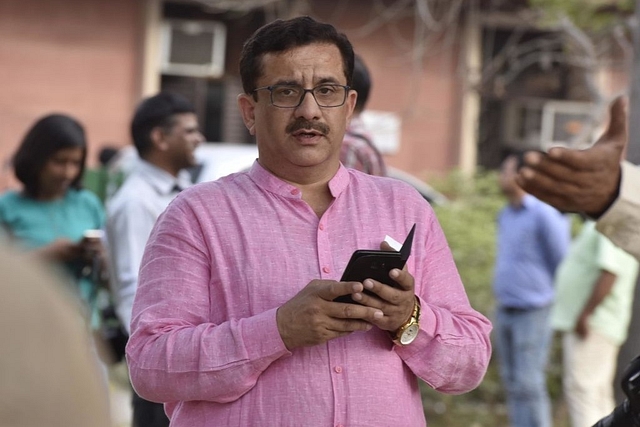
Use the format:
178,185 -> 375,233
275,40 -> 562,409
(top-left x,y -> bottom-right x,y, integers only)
0,0 -> 142,187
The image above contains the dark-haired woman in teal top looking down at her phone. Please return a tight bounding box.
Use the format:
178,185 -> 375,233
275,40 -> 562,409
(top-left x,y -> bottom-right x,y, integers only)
0,114 -> 106,320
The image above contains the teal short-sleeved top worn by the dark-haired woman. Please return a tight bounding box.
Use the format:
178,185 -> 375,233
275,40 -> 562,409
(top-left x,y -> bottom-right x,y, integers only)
0,189 -> 105,323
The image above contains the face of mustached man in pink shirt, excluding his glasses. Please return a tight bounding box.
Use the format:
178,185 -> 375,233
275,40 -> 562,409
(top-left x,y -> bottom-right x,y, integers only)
238,43 -> 357,179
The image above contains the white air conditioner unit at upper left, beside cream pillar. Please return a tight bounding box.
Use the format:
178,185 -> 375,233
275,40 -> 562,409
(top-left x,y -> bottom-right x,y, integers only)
161,19 -> 227,77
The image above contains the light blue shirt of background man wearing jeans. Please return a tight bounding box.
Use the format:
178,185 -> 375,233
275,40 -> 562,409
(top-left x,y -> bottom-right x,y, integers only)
493,194 -> 571,309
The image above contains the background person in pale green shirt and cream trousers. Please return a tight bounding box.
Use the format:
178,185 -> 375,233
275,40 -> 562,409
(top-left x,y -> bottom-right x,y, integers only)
551,221 -> 638,427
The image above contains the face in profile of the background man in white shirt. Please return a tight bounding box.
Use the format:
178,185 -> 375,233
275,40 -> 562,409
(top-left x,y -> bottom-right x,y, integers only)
161,113 -> 204,172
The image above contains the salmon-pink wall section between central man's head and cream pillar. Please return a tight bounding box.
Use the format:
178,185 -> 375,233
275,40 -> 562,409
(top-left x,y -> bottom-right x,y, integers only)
310,0 -> 462,178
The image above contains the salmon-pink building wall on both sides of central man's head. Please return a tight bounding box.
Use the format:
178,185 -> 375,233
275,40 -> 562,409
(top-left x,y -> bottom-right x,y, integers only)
0,0 -> 461,188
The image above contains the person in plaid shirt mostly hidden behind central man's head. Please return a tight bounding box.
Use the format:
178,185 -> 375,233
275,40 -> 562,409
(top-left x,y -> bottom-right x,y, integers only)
340,55 -> 387,176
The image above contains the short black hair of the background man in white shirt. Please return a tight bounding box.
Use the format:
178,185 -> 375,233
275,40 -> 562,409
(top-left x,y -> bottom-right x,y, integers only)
131,92 -> 195,157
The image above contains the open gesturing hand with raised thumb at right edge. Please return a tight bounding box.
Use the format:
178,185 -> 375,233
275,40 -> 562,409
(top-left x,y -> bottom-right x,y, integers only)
516,97 -> 628,218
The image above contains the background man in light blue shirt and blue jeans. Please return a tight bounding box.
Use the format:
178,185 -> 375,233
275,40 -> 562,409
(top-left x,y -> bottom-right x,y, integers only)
493,155 -> 571,427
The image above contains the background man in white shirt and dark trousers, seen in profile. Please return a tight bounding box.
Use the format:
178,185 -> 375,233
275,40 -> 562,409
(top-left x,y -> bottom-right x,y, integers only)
106,92 -> 204,427
